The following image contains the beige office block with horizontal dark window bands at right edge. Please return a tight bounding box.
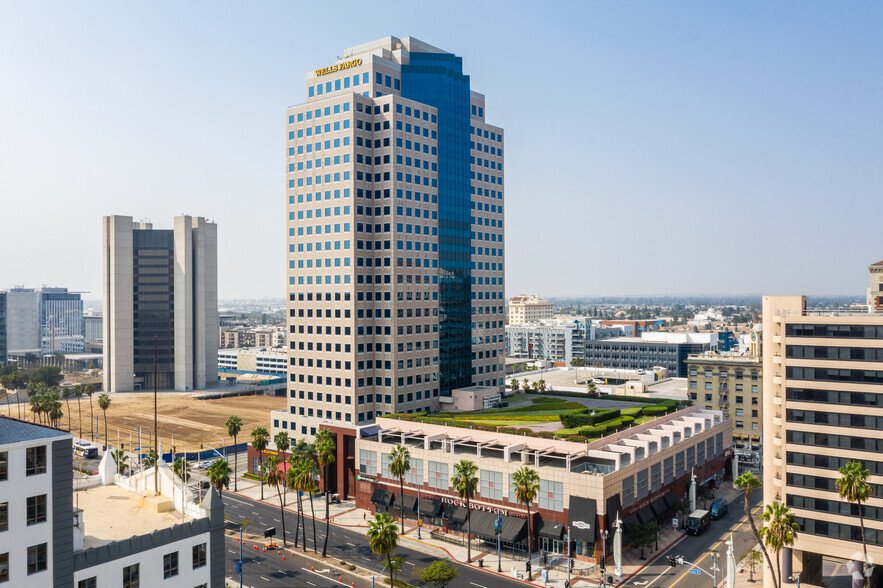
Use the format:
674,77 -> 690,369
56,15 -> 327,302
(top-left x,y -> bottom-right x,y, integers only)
763,296 -> 883,586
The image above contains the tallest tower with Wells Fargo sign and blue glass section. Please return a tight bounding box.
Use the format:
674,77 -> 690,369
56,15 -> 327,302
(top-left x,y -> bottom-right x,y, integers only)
273,37 -> 505,454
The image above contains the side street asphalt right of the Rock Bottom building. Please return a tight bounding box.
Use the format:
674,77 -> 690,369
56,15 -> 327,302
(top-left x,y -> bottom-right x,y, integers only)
622,490 -> 762,588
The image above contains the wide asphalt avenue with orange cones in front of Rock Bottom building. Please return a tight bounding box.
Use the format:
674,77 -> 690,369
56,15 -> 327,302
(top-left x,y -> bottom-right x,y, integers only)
222,492 -> 524,588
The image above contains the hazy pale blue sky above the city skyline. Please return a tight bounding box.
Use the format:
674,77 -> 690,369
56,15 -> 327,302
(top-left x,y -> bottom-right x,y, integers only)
0,0 -> 883,298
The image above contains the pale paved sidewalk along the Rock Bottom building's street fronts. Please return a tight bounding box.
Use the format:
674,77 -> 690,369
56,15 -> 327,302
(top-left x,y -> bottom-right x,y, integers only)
229,478 -> 744,588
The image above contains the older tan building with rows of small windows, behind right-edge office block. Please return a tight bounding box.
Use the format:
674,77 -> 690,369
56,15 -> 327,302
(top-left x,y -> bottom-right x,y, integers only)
687,331 -> 763,445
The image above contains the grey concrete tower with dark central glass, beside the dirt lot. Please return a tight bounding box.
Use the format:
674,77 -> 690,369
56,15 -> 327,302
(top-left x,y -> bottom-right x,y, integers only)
103,216 -> 218,392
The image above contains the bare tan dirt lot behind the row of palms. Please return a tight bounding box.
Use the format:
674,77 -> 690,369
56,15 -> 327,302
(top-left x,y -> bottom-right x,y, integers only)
11,392 -> 286,451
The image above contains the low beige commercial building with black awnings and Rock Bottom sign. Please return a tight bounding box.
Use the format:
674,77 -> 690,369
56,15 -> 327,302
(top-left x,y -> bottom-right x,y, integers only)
356,406 -> 732,562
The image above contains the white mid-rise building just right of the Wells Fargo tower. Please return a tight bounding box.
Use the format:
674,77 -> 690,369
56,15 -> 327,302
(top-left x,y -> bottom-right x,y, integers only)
506,320 -> 586,365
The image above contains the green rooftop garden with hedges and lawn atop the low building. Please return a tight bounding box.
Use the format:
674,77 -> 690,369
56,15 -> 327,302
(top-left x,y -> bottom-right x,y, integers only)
384,394 -> 679,443
